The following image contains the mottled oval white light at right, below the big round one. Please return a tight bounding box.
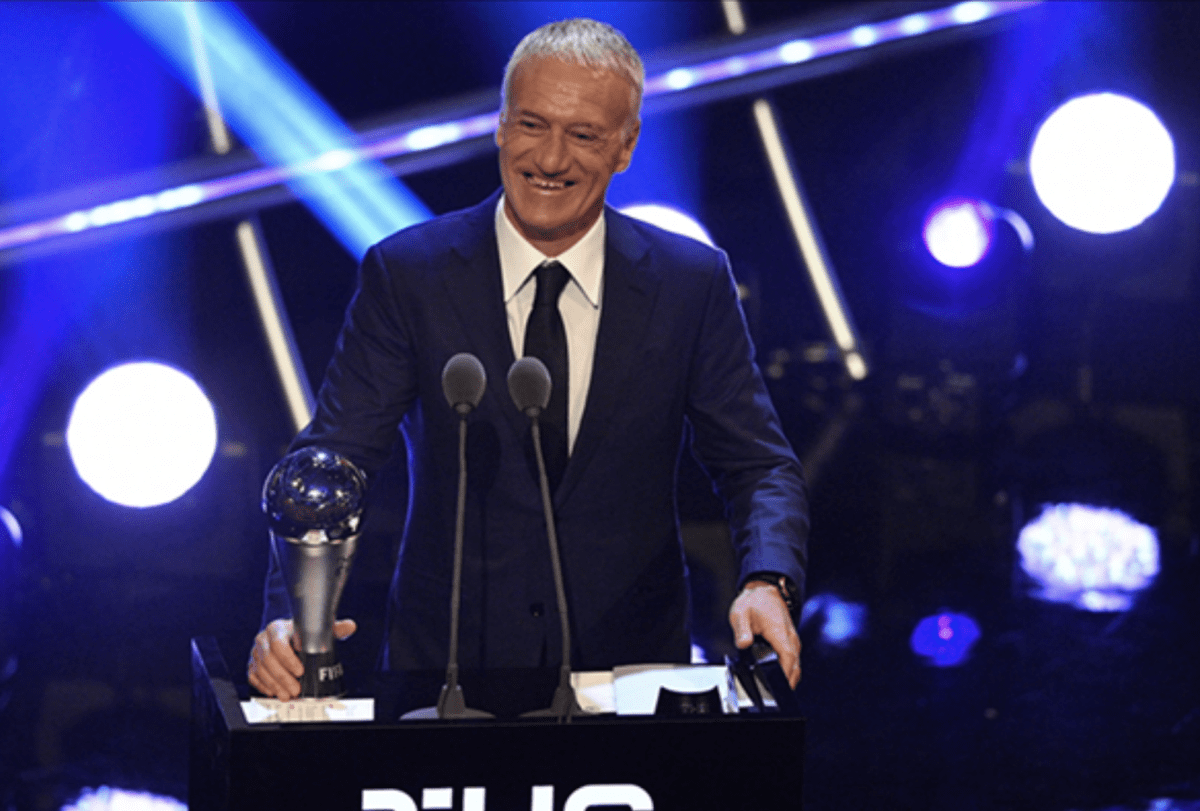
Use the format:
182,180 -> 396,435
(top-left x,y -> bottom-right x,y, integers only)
1016,504 -> 1158,612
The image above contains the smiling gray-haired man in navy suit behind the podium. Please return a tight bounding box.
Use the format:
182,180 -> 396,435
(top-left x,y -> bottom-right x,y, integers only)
248,19 -> 808,698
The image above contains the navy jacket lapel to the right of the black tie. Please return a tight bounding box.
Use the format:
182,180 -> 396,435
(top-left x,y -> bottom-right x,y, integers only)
554,208 -> 661,504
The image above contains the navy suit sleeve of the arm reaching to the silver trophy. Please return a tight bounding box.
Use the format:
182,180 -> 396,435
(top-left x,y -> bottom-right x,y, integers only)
263,246 -> 416,626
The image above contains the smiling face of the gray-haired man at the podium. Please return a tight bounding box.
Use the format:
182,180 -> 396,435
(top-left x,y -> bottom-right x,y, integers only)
496,58 -> 638,257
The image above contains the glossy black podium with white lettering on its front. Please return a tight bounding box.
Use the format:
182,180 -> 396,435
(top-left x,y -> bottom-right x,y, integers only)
188,637 -> 804,811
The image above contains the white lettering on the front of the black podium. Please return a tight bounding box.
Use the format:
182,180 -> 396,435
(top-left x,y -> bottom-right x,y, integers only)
362,783 -> 654,811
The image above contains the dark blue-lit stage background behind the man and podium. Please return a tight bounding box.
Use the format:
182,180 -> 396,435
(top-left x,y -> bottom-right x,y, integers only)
0,1 -> 1200,811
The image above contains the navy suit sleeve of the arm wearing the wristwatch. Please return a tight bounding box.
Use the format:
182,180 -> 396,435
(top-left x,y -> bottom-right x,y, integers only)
686,253 -> 809,602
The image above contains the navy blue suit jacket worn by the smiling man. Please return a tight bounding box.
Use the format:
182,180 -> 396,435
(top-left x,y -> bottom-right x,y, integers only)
266,196 -> 808,669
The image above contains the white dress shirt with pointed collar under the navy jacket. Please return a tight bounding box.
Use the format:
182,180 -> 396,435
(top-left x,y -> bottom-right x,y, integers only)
496,194 -> 606,450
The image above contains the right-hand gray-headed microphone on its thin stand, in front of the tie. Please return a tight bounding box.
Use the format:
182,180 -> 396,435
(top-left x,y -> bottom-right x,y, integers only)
509,356 -> 583,723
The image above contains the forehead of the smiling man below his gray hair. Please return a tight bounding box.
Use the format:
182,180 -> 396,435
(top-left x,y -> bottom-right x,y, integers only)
506,56 -> 632,122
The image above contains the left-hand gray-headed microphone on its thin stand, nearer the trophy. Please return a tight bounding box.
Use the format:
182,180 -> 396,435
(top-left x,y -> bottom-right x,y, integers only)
401,352 -> 496,720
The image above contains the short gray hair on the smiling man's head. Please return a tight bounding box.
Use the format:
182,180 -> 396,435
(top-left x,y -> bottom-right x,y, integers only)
500,17 -> 646,121
